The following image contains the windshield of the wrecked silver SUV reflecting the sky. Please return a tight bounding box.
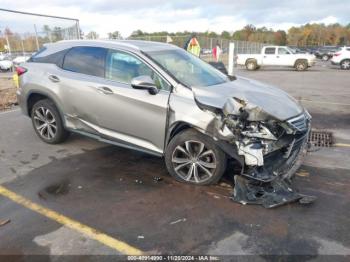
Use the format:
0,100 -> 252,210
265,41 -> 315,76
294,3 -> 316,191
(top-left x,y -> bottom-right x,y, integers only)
147,49 -> 229,87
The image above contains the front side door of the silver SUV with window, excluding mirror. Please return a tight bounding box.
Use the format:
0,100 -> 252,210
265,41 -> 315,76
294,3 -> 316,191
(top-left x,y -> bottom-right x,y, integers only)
91,50 -> 171,154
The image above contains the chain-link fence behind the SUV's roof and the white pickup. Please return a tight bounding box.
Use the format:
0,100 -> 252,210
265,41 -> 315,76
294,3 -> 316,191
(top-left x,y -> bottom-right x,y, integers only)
129,35 -> 267,67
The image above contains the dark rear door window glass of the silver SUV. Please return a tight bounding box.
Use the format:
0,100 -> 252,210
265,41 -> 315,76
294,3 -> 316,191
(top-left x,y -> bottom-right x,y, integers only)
63,46 -> 107,77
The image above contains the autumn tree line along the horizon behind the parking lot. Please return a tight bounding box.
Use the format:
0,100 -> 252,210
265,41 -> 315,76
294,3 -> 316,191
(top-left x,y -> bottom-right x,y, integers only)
0,23 -> 350,52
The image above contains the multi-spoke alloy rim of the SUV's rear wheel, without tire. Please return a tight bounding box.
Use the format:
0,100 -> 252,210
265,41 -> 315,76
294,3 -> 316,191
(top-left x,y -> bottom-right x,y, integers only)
33,107 -> 57,140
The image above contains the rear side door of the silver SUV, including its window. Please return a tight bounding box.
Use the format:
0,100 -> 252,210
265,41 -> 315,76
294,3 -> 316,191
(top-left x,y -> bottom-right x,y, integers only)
58,46 -> 107,132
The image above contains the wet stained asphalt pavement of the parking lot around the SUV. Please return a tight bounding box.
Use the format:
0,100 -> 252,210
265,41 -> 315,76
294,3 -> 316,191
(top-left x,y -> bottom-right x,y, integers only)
0,62 -> 350,261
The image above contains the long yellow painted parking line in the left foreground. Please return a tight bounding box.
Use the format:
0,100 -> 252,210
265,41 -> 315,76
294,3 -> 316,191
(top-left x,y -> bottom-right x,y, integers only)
0,186 -> 143,255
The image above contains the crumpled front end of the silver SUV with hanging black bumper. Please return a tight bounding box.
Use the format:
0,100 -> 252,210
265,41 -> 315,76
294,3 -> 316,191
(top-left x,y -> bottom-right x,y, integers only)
196,87 -> 314,208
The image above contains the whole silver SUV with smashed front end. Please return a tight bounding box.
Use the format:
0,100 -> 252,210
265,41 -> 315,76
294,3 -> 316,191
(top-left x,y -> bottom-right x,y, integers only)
17,40 -> 310,205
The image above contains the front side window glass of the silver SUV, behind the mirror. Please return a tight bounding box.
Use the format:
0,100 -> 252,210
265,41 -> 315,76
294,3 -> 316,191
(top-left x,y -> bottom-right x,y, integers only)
106,50 -> 170,91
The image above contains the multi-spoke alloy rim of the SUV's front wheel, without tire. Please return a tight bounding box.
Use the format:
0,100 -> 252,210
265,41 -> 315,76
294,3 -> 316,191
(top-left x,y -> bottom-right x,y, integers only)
171,140 -> 217,183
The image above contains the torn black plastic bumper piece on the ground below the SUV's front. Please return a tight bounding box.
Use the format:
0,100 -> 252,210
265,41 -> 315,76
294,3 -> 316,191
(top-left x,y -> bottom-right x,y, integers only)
231,175 -> 316,208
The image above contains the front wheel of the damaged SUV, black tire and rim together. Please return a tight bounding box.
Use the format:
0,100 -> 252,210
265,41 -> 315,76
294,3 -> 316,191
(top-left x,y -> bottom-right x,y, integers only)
165,129 -> 227,185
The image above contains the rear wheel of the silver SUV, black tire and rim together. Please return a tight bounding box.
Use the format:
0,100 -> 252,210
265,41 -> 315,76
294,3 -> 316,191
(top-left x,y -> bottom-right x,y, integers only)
30,99 -> 69,144
